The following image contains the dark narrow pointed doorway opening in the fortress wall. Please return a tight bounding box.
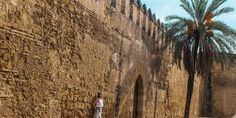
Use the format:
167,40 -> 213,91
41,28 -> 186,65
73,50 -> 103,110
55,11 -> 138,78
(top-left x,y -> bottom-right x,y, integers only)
133,76 -> 143,118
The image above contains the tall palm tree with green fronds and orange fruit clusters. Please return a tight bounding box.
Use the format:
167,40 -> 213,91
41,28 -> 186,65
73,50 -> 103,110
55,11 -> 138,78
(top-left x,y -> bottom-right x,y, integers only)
165,0 -> 236,118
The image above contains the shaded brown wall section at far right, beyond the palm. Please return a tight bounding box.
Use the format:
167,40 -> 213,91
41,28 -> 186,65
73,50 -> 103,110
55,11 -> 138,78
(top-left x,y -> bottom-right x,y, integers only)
212,55 -> 236,118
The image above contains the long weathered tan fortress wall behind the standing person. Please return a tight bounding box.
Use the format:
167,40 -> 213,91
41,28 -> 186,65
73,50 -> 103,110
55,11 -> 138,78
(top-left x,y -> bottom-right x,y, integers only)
0,0 -> 199,118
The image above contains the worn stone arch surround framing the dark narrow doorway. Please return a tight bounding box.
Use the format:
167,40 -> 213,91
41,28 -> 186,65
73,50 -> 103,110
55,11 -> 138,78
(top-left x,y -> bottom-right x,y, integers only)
117,62 -> 150,118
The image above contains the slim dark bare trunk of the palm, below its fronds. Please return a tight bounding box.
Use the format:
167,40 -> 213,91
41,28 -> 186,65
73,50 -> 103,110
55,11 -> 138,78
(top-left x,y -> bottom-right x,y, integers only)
184,73 -> 194,118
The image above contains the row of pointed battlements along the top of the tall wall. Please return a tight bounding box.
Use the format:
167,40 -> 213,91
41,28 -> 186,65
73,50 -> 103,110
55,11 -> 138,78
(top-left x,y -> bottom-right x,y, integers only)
76,0 -> 163,40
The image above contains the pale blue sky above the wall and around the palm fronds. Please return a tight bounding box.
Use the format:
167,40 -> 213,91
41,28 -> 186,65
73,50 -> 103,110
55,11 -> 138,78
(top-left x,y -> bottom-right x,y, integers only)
141,0 -> 236,29
